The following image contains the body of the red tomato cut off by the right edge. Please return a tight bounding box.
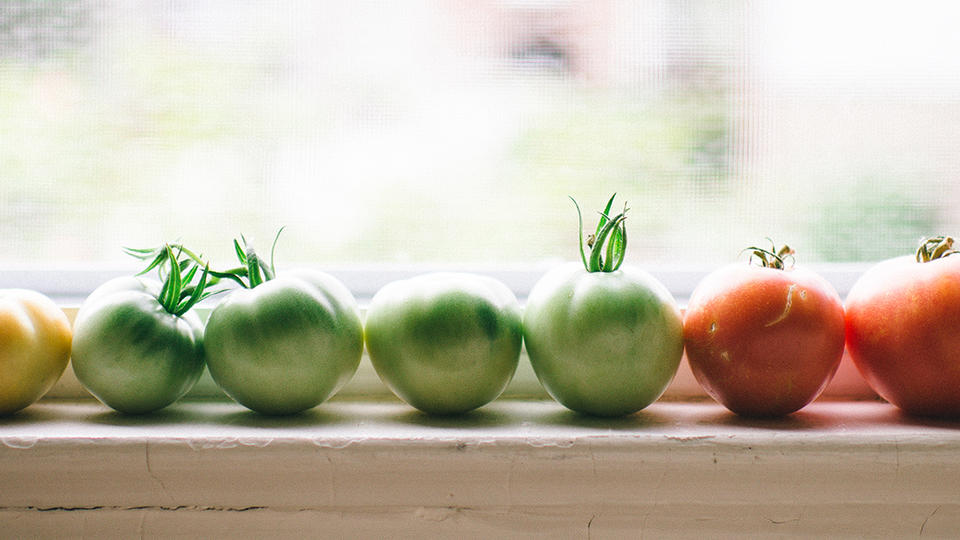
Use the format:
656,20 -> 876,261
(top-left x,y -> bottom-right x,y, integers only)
846,255 -> 960,417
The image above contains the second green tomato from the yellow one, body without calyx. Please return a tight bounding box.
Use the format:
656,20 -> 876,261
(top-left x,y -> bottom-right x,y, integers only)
206,271 -> 363,415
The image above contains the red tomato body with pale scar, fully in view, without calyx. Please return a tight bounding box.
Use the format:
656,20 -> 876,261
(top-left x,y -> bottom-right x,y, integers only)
683,264 -> 844,416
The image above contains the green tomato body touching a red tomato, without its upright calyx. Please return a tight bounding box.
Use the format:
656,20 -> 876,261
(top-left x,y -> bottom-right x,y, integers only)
524,264 -> 683,416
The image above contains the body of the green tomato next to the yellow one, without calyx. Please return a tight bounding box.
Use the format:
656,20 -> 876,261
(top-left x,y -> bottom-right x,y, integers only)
72,277 -> 204,414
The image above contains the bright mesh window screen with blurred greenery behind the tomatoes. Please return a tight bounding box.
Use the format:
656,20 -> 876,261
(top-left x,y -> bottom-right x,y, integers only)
0,0 -> 960,265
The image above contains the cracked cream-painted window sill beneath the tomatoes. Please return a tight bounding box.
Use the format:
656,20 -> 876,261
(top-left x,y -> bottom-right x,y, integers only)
0,400 -> 960,537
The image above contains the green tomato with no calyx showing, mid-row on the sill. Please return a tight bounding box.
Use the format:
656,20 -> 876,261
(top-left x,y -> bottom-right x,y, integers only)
365,273 -> 523,414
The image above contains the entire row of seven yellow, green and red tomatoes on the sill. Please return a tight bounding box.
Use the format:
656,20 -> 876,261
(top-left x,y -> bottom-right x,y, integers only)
0,209 -> 960,416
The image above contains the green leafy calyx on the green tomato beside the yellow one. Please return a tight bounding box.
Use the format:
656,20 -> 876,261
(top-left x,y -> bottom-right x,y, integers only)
123,243 -> 223,317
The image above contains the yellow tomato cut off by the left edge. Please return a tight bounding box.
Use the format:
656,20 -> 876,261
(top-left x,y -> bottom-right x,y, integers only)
0,289 -> 71,415
